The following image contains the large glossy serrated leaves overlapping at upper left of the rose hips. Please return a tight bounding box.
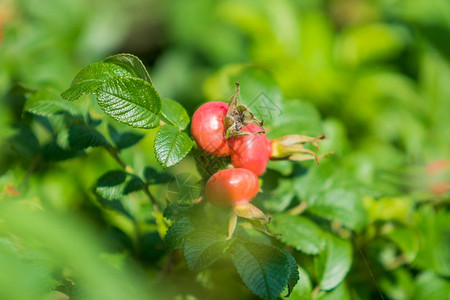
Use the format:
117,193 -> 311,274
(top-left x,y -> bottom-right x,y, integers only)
62,54 -> 161,128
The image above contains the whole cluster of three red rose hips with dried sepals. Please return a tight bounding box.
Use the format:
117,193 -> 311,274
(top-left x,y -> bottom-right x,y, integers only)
191,83 -> 325,237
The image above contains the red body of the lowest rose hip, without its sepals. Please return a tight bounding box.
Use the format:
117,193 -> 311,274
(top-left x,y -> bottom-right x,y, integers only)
205,168 -> 259,207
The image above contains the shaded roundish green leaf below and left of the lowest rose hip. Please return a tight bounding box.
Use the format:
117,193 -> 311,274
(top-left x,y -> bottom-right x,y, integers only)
184,230 -> 229,272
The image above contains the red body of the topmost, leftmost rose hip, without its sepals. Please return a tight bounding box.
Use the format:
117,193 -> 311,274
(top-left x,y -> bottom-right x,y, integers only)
191,102 -> 230,156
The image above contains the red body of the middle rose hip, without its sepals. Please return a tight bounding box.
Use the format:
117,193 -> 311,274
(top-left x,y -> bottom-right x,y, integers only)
229,124 -> 271,176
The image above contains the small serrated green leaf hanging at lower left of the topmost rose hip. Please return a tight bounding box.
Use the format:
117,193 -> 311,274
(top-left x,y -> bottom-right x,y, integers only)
155,125 -> 194,167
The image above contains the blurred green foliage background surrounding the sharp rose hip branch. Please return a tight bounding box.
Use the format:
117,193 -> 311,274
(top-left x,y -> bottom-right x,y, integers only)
0,0 -> 450,300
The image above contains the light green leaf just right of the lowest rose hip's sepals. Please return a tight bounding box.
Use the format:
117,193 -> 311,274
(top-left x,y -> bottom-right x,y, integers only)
269,215 -> 326,254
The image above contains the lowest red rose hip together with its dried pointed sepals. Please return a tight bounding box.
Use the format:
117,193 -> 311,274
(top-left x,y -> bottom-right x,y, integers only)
205,168 -> 269,239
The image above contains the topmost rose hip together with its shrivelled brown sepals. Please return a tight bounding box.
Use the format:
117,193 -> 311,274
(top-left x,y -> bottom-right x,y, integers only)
191,83 -> 264,157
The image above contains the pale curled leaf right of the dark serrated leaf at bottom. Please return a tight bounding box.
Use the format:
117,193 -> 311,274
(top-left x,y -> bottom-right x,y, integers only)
315,234 -> 352,290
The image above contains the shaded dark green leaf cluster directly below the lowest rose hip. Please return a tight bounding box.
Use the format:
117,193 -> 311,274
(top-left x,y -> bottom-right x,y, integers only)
164,204 -> 299,299
